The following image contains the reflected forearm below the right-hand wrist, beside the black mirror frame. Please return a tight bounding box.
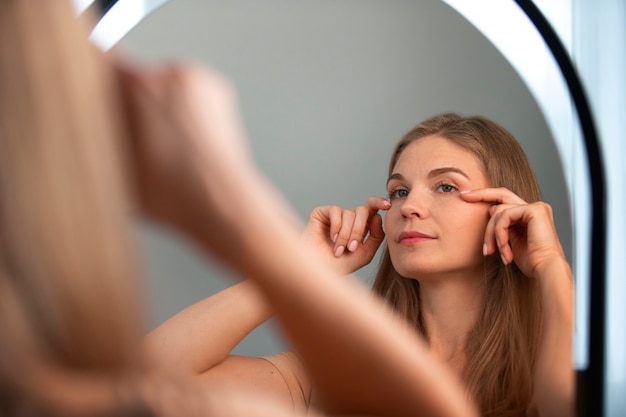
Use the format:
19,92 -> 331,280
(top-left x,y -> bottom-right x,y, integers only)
535,259 -> 575,417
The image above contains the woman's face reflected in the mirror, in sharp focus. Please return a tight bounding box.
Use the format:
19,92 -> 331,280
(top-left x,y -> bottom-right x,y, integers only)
385,136 -> 490,280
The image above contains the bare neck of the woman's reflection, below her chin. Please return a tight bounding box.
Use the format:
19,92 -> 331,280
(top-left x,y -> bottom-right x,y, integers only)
420,272 -> 485,369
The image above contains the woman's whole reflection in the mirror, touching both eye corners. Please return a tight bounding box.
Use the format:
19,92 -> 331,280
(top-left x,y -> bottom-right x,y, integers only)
147,114 -> 574,417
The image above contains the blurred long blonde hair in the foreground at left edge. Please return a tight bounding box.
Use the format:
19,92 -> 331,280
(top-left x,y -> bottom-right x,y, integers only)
0,0 -> 143,415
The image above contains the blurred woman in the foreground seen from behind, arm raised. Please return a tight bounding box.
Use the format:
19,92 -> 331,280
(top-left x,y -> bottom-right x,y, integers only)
0,0 -> 476,417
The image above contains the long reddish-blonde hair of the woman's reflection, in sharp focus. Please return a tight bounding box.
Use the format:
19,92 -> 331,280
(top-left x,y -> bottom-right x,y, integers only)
374,114 -> 541,417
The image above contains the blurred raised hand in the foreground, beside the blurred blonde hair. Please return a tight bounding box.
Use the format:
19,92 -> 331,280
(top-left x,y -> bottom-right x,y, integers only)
114,60 -> 247,226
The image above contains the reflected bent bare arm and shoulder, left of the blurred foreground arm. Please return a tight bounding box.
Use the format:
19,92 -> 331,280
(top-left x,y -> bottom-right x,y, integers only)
145,281 -> 310,410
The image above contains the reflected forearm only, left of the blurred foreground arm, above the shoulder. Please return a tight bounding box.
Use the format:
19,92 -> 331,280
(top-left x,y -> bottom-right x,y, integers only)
145,281 -> 270,375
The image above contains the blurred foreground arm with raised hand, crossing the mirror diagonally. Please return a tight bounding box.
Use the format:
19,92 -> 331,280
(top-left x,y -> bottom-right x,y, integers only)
119,61 -> 478,416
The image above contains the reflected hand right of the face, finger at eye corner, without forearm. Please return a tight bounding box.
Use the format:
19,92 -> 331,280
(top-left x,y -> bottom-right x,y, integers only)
460,187 -> 565,277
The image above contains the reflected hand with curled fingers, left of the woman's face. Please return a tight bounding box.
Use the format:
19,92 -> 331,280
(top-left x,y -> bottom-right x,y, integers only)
302,197 -> 391,275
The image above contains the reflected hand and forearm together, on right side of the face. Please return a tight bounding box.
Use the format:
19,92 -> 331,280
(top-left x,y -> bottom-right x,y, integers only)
460,188 -> 575,416
